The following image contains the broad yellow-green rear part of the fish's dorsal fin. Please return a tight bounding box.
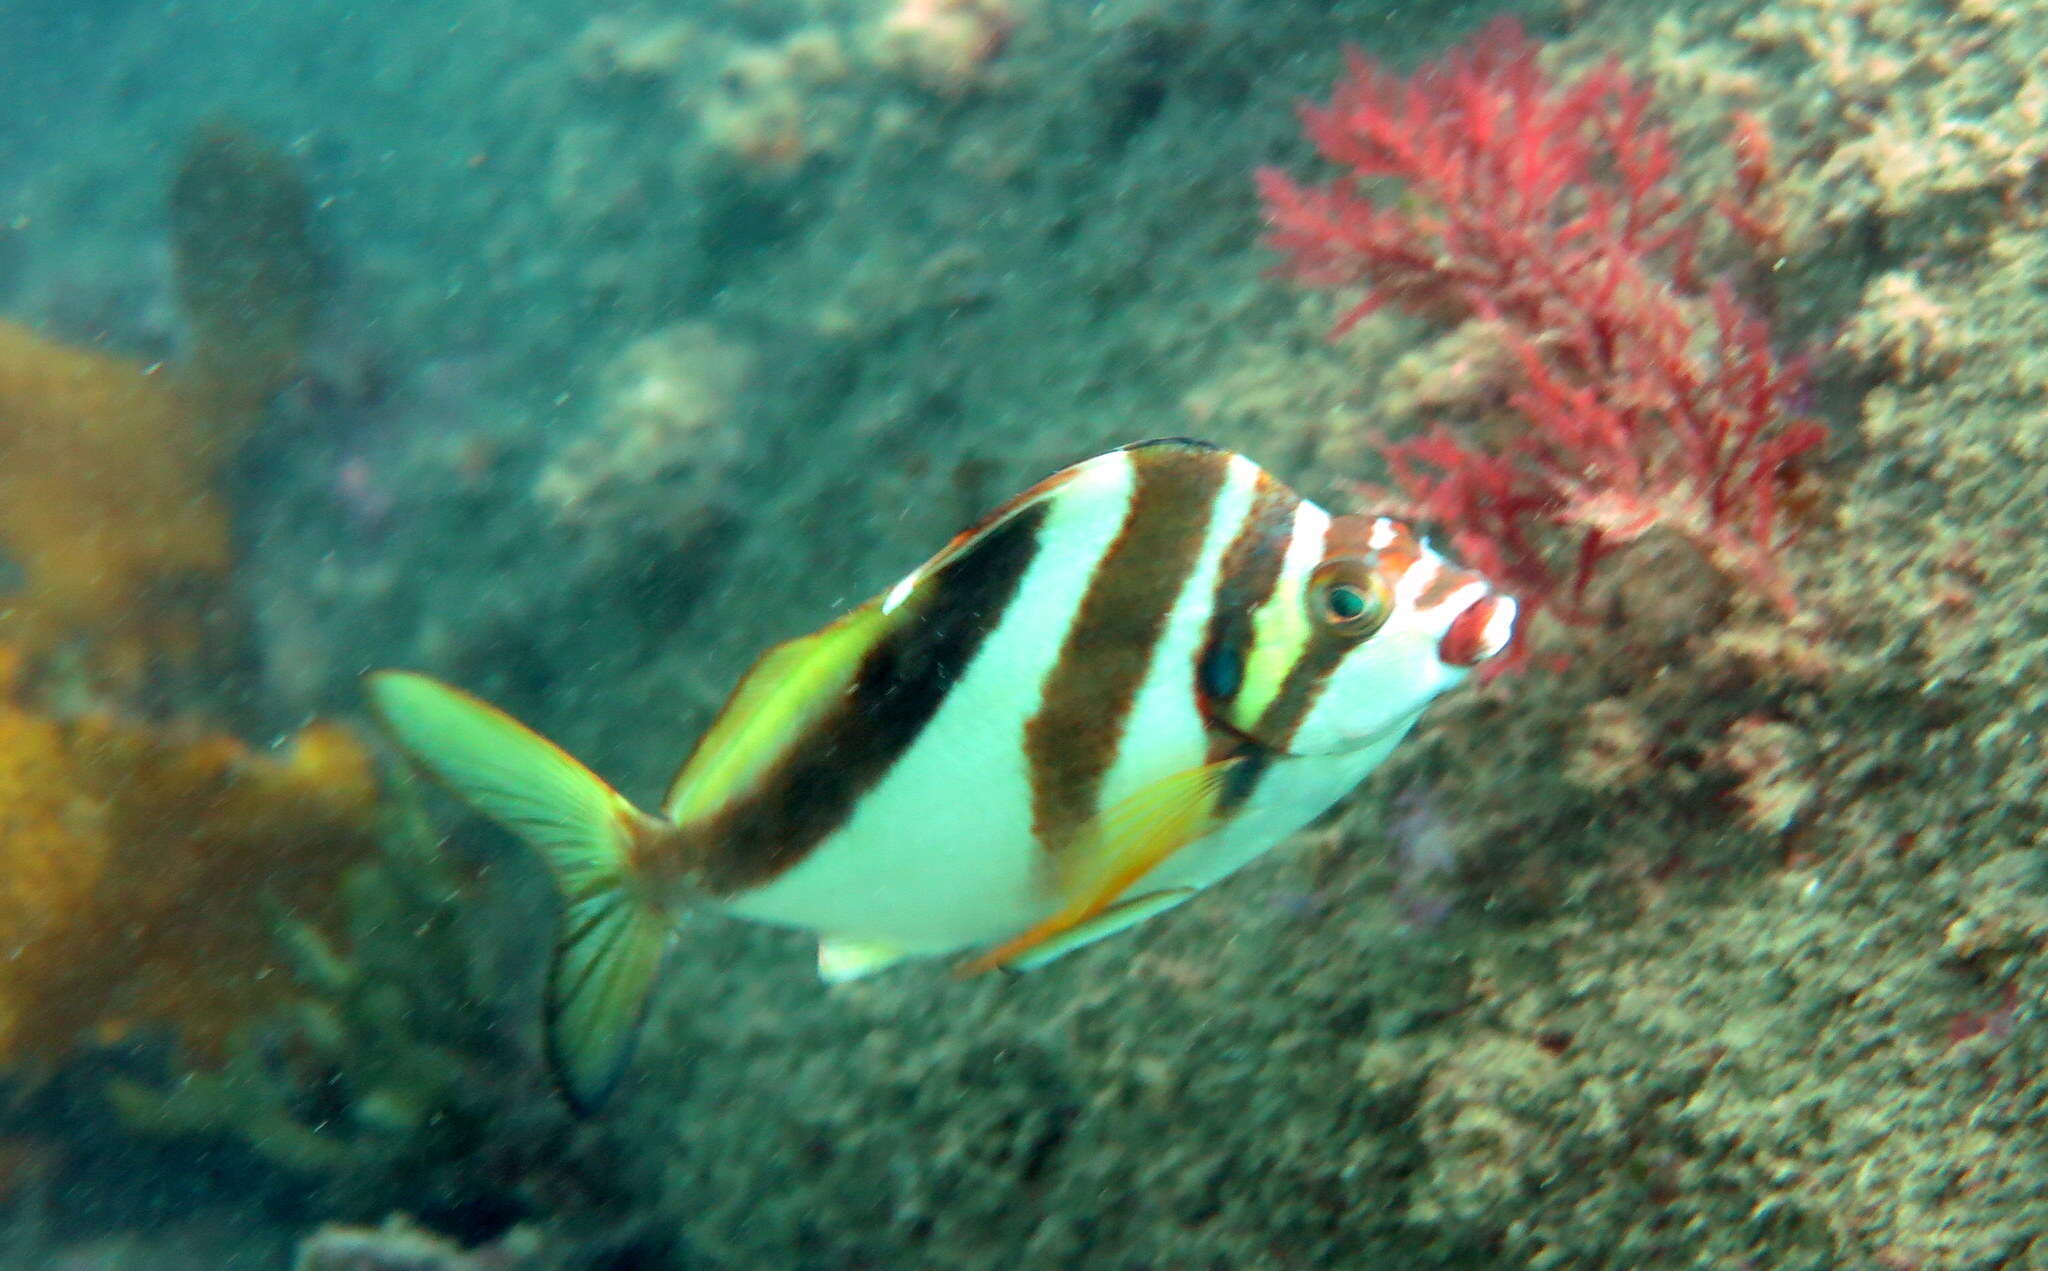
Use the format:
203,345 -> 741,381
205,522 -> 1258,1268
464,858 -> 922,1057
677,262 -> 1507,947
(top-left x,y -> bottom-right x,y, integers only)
662,600 -> 897,825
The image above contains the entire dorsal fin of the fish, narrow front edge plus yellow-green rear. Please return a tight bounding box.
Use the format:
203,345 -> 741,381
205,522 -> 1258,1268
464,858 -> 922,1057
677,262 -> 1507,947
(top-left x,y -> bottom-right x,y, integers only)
664,458 -> 1102,823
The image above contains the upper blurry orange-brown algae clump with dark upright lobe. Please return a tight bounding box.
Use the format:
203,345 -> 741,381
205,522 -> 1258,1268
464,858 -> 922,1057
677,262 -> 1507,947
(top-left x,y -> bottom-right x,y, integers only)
0,125 -> 322,677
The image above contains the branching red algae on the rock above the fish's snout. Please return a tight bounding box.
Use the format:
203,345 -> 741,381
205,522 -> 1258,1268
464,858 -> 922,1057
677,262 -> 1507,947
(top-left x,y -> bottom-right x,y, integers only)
1260,20 -> 1823,634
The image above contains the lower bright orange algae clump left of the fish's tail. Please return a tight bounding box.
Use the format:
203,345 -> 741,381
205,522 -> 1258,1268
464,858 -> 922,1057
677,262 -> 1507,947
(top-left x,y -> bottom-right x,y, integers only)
0,647 -> 377,1064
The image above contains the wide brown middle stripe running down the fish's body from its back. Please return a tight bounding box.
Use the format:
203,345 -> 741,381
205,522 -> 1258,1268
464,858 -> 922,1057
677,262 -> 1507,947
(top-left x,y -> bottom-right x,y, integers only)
1024,442 -> 1231,851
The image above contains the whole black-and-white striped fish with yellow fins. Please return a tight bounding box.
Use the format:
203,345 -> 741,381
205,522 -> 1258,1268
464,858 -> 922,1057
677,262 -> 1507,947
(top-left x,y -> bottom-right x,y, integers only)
371,440 -> 1516,1107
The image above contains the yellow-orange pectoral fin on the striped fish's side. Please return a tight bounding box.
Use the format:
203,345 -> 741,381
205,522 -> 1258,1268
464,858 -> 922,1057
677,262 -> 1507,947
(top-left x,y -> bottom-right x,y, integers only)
961,757 -> 1247,974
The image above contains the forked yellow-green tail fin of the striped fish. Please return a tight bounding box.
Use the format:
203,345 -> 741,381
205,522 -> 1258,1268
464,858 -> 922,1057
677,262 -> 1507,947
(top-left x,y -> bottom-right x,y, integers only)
369,671 -> 672,1111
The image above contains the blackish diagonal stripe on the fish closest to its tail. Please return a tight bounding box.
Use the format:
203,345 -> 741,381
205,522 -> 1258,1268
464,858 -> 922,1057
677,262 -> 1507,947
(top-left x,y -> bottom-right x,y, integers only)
690,503 -> 1049,894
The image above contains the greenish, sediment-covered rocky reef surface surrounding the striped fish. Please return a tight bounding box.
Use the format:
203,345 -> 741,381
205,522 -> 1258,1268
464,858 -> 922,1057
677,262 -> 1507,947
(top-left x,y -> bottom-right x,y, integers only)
0,0 -> 2048,1271
